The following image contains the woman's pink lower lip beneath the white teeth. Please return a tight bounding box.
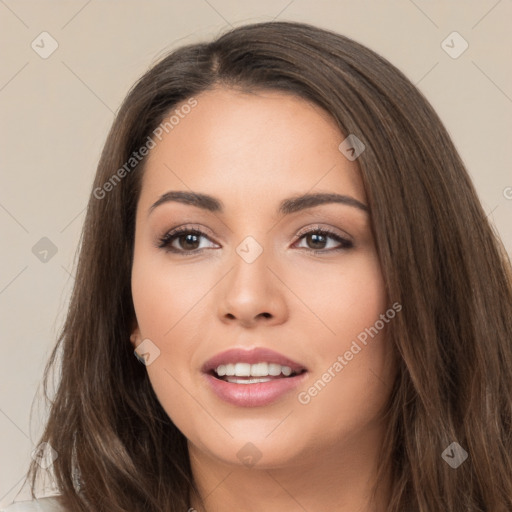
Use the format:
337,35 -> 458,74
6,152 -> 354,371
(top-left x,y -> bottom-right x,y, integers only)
203,372 -> 307,407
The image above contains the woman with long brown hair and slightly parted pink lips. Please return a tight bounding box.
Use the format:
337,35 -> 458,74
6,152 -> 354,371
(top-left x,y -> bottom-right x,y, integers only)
8,22 -> 512,512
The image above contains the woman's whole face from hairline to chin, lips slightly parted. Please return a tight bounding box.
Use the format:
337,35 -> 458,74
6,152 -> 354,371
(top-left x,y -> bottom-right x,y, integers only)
132,89 -> 397,468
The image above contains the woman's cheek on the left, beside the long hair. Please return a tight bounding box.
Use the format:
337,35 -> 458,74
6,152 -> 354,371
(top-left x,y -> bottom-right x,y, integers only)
131,244 -> 218,398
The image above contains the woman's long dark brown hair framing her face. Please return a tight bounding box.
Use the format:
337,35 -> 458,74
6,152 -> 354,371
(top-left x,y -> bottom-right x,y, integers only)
27,22 -> 512,512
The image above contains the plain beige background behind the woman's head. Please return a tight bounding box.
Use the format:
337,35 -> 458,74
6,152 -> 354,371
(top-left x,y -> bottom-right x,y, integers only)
0,0 -> 512,506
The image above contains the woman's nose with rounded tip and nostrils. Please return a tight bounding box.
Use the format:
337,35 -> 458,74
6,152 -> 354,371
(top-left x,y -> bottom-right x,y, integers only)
216,245 -> 288,328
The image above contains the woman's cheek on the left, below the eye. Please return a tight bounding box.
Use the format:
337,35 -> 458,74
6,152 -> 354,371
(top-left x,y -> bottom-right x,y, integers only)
132,254 -> 205,431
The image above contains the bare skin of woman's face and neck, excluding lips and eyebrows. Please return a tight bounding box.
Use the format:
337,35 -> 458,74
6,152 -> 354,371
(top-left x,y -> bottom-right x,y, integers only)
131,88 -> 394,512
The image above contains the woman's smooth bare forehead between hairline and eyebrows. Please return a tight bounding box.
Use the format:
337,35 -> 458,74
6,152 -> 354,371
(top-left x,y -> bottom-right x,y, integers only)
141,88 -> 365,211
